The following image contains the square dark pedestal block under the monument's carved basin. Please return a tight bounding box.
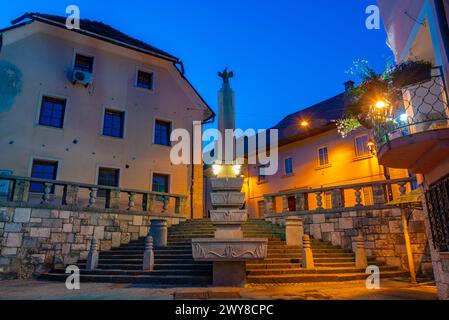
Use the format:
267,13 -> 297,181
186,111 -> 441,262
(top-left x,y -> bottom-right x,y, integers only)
213,261 -> 246,288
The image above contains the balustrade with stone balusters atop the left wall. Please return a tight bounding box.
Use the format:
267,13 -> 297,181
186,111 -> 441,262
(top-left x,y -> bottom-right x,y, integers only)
0,175 -> 187,215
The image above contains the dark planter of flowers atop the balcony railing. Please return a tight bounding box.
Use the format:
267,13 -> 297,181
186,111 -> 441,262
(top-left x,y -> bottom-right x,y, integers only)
390,61 -> 433,89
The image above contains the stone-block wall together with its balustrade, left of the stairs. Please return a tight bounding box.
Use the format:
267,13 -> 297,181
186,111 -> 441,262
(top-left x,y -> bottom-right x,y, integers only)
0,176 -> 187,279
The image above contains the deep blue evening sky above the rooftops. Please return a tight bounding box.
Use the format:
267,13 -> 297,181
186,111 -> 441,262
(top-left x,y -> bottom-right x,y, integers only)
0,0 -> 392,129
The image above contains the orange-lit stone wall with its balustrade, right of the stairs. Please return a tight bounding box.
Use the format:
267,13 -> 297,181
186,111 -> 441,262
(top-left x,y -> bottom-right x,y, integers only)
265,179 -> 432,275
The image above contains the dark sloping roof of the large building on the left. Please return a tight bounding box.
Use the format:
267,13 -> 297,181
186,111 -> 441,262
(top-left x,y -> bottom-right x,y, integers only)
12,12 -> 179,61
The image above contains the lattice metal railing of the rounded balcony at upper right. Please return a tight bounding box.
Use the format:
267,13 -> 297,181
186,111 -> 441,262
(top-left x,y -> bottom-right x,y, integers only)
374,67 -> 449,148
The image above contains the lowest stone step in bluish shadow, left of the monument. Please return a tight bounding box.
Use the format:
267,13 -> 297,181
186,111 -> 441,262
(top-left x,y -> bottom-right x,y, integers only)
40,272 -> 212,287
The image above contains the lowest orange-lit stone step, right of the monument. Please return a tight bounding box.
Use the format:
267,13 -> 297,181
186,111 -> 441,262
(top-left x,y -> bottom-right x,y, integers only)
246,271 -> 404,284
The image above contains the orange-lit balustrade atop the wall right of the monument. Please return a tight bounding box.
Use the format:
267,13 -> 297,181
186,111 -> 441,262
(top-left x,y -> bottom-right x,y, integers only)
264,178 -> 416,218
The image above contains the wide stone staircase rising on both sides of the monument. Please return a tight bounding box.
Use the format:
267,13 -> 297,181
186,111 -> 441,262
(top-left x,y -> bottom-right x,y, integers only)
41,220 -> 404,287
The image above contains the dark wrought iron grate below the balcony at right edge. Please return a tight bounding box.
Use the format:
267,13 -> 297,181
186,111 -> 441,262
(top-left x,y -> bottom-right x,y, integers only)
426,177 -> 449,252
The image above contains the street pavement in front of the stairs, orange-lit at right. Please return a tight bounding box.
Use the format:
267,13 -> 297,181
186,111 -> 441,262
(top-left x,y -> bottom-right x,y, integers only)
0,280 -> 438,300
